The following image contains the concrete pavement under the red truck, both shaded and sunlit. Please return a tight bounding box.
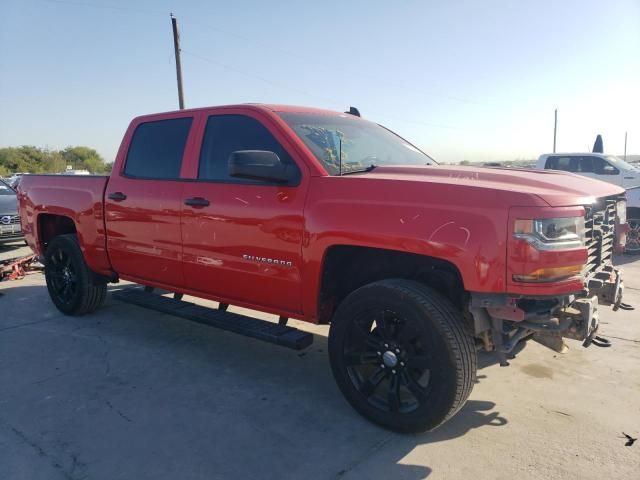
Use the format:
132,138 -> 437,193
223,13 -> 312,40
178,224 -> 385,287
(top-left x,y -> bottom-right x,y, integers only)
0,242 -> 640,480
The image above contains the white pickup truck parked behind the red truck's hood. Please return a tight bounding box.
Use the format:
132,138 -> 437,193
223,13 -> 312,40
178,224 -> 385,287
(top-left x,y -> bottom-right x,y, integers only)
536,153 -> 640,254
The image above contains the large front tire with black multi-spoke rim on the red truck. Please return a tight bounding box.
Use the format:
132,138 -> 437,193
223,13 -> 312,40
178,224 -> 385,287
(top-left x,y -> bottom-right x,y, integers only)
329,279 -> 477,433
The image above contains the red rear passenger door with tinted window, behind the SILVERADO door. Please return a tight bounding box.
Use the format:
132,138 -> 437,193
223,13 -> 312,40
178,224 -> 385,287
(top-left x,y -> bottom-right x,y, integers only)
105,114 -> 194,287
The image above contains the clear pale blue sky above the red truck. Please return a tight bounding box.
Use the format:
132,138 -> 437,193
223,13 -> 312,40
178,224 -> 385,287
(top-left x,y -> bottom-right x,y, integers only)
0,0 -> 640,162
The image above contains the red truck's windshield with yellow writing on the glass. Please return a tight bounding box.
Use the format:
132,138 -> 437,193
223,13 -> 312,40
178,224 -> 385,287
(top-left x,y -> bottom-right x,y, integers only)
279,112 -> 435,175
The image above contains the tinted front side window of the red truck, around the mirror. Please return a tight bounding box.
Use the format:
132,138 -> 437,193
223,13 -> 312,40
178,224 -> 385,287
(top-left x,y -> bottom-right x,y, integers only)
198,115 -> 300,185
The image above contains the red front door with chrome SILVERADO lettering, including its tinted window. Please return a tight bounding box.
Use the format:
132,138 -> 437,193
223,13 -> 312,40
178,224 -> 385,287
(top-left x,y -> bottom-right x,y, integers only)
182,112 -> 308,312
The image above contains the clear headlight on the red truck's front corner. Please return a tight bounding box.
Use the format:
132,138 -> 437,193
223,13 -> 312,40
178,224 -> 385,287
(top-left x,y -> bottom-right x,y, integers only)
513,217 -> 585,250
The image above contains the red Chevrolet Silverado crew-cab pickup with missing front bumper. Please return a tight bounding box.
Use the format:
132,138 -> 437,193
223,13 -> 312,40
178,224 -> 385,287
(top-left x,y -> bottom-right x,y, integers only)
19,105 -> 625,432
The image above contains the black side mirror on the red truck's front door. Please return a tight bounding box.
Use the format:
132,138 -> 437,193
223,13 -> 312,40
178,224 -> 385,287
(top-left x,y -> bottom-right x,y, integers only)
229,150 -> 298,183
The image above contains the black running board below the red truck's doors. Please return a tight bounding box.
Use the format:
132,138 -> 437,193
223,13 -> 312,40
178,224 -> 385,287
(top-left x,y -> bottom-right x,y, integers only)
112,287 -> 313,350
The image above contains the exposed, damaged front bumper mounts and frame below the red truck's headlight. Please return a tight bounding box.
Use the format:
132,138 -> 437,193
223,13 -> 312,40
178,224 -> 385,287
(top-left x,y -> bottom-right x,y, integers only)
469,265 -> 632,365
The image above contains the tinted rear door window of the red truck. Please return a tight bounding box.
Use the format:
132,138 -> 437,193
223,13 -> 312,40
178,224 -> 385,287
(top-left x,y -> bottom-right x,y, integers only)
124,117 -> 193,179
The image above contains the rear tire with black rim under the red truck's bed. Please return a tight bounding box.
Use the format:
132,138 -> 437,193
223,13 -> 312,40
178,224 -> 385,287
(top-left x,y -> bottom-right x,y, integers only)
44,234 -> 107,315
